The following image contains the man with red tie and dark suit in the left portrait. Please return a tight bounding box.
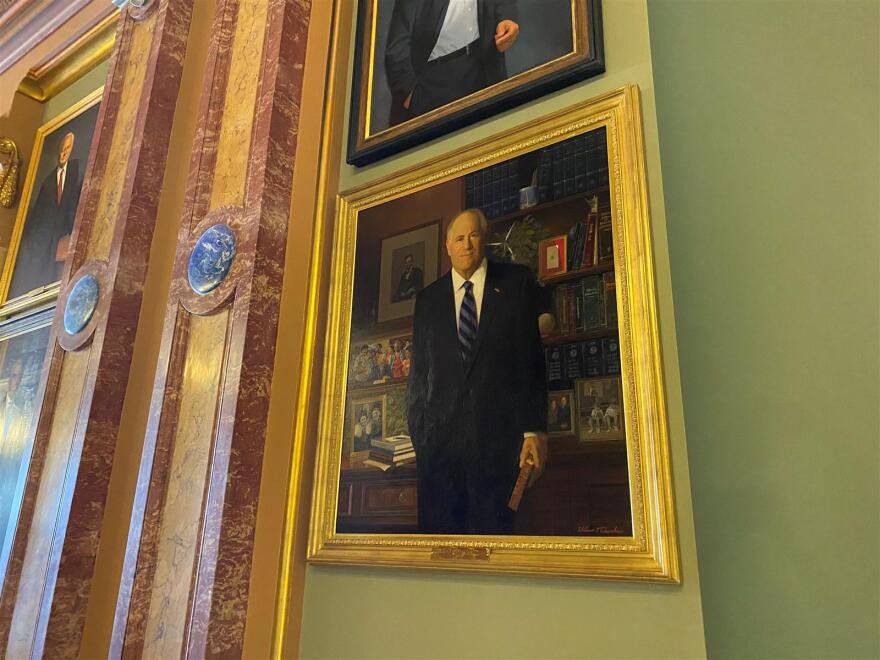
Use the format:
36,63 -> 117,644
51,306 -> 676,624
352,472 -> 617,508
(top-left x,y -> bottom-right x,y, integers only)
9,133 -> 82,298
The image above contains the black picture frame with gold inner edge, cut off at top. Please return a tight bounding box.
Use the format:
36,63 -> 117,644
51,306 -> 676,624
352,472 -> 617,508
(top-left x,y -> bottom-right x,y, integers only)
346,0 -> 605,167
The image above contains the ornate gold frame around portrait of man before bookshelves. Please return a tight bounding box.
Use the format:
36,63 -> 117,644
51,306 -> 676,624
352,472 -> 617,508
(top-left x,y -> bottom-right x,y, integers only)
308,86 -> 680,583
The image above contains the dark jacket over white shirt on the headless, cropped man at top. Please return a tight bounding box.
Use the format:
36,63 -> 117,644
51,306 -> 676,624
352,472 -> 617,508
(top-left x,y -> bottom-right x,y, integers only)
385,0 -> 517,107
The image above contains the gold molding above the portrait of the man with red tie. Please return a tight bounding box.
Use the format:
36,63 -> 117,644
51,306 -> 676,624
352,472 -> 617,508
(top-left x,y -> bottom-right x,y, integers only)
18,11 -> 119,103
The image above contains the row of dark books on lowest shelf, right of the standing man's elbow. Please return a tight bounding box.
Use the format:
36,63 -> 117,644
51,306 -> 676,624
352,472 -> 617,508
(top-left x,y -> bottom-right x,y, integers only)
544,337 -> 620,390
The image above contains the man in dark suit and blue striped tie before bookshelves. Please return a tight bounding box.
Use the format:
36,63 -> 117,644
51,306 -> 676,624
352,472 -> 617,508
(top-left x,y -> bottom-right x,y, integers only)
407,209 -> 547,534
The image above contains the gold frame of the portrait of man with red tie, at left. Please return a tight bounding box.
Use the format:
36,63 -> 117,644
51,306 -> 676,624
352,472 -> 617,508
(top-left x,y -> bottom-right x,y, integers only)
0,85 -> 104,316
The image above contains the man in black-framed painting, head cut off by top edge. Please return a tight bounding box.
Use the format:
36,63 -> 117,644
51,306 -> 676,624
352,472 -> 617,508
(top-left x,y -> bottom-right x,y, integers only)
385,0 -> 519,126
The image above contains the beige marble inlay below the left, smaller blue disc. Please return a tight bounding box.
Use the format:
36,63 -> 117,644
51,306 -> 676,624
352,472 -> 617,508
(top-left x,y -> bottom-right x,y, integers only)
6,349 -> 91,658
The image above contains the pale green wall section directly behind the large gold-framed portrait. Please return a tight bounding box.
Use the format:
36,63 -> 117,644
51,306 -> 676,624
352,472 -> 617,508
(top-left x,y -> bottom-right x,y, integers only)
301,0 -> 705,658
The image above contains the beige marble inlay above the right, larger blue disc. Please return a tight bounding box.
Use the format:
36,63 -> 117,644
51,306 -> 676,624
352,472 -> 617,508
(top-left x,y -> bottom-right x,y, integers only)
211,2 -> 269,209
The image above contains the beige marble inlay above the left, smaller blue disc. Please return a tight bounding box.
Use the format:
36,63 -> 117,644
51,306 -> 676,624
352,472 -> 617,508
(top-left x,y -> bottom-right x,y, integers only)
87,12 -> 159,259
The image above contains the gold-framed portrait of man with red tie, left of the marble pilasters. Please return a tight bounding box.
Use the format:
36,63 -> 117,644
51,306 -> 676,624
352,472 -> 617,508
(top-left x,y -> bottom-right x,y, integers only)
0,88 -> 103,304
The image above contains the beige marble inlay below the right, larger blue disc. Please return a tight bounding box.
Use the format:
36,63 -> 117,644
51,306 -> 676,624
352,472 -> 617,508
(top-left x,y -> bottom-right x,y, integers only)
144,308 -> 229,658
